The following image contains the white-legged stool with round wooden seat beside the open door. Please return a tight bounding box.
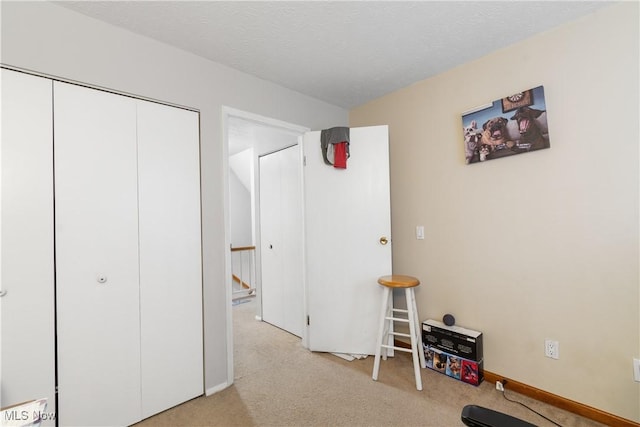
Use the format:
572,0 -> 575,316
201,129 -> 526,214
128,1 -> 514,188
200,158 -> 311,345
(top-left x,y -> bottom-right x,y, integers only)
372,274 -> 427,390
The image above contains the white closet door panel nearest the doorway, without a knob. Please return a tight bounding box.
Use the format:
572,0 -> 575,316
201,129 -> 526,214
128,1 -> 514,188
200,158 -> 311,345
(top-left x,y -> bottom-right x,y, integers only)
138,101 -> 203,417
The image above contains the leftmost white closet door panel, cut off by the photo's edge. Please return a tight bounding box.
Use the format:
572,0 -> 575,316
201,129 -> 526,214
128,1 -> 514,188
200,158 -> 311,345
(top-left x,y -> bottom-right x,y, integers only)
0,69 -> 56,425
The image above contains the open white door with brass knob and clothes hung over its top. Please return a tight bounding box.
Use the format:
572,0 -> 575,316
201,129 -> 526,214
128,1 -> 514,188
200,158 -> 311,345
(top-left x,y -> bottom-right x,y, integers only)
303,126 -> 391,354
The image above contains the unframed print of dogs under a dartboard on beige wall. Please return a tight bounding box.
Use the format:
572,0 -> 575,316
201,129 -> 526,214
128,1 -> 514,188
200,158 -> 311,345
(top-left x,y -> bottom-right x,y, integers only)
462,86 -> 551,164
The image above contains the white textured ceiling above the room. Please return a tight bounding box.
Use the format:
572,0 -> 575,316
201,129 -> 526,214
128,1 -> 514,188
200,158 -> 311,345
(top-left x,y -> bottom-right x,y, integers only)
55,1 -> 611,108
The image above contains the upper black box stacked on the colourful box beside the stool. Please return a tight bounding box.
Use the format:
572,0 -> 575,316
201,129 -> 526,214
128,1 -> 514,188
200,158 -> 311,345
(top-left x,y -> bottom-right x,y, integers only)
422,319 -> 483,362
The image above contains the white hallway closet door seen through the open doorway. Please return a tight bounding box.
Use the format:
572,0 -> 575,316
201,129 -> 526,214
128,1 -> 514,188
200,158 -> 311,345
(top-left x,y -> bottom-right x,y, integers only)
260,145 -> 304,336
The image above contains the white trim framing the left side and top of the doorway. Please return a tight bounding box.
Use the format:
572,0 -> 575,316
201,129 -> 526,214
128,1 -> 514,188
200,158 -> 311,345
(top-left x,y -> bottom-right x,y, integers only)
222,105 -> 310,385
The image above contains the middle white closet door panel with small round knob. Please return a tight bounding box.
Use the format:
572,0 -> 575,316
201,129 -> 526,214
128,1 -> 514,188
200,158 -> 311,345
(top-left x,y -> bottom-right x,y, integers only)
54,82 -> 140,425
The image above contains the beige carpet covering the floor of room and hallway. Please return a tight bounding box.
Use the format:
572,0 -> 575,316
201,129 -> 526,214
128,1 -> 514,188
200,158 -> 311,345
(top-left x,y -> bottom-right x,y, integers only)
138,300 -> 602,427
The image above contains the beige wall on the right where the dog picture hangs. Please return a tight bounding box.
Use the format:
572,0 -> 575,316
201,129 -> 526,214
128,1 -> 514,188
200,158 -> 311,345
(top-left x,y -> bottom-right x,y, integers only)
350,2 -> 640,421
